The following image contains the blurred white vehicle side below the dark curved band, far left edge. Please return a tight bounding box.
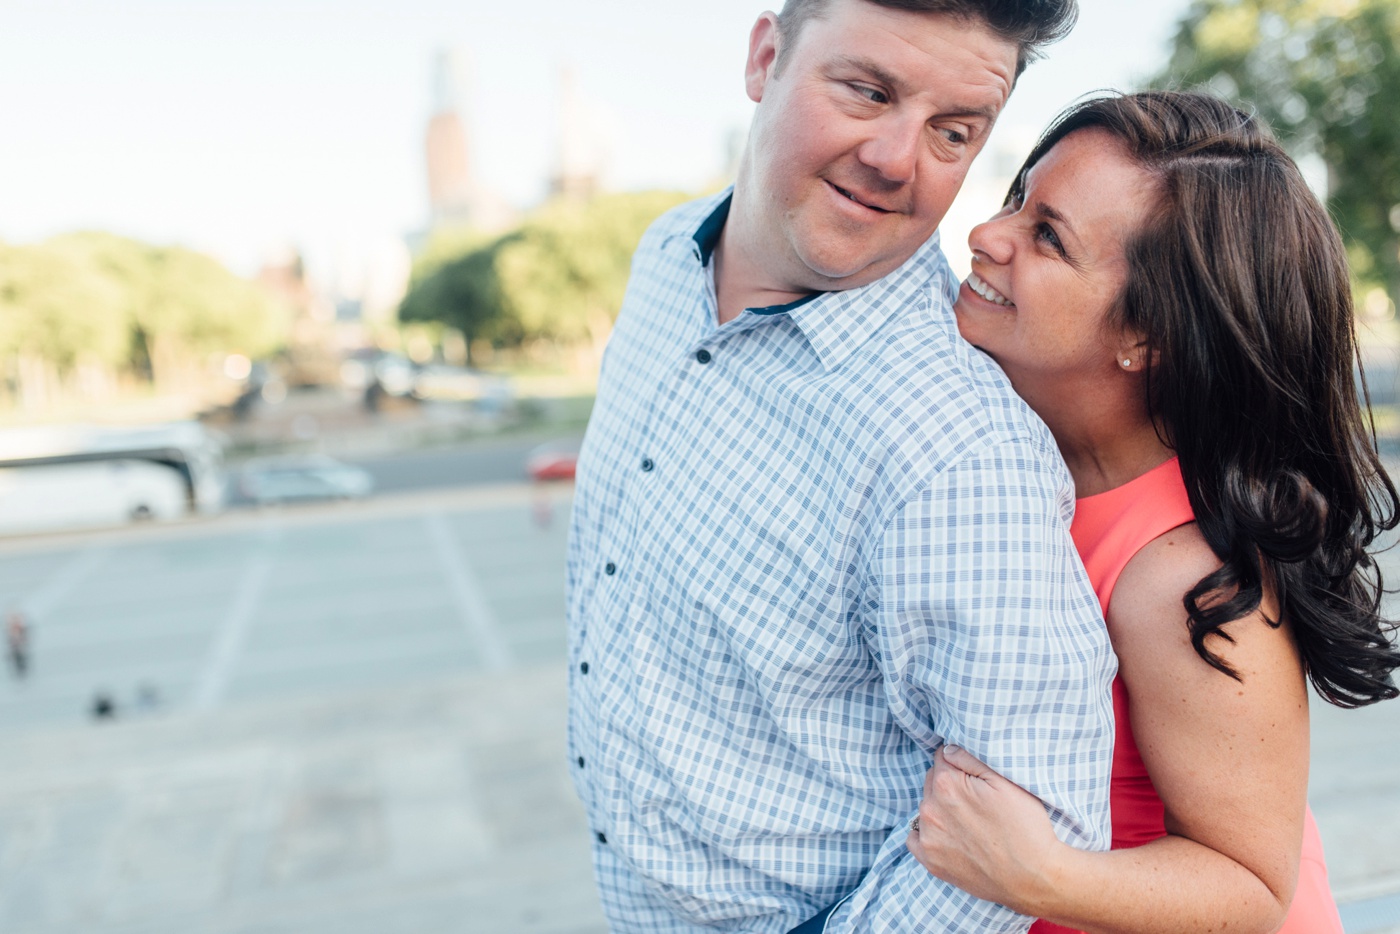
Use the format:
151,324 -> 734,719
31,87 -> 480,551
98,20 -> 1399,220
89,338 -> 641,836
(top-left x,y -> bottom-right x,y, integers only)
0,458 -> 189,534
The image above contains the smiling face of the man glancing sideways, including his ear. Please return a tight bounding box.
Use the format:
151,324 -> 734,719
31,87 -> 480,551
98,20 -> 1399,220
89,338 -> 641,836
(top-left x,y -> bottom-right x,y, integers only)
735,0 -> 1016,293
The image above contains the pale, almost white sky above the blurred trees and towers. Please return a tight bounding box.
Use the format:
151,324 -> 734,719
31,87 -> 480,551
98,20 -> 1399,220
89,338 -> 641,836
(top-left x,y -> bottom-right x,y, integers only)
0,0 -> 1186,272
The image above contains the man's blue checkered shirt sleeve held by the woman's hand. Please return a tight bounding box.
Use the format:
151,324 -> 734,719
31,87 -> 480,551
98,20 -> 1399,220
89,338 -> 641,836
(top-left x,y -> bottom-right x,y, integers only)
826,442 -> 1116,934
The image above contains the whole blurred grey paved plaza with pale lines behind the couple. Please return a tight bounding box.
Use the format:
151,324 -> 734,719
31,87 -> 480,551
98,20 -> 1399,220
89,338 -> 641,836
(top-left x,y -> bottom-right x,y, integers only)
0,486 -> 1400,934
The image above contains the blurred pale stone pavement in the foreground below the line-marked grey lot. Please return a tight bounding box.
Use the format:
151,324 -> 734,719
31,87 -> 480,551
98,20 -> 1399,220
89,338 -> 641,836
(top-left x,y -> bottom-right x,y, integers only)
0,665 -> 606,934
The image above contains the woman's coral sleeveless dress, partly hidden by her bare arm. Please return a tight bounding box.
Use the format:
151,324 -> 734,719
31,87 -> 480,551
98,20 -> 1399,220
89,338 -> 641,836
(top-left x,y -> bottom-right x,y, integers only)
1030,458 -> 1343,934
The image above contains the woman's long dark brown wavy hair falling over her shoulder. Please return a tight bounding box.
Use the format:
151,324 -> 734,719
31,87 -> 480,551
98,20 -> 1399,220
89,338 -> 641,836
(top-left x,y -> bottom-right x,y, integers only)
1012,91 -> 1400,707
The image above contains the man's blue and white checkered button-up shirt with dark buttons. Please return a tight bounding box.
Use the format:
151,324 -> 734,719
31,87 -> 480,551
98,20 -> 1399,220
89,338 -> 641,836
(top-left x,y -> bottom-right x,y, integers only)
568,193 -> 1116,934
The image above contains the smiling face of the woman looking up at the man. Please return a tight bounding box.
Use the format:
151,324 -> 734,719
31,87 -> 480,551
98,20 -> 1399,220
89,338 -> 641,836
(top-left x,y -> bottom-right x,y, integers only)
953,129 -> 1156,403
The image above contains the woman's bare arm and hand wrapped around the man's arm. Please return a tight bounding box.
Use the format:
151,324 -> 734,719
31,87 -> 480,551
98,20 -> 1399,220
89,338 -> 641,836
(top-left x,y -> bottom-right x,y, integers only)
909,525 -> 1308,934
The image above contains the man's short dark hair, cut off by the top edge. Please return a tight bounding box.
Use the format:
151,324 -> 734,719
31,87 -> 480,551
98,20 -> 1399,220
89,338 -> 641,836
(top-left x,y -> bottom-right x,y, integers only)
776,0 -> 1079,77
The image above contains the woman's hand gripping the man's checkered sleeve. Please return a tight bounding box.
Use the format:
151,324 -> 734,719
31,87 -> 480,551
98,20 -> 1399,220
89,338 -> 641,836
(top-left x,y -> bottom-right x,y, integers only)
907,746 -> 1064,916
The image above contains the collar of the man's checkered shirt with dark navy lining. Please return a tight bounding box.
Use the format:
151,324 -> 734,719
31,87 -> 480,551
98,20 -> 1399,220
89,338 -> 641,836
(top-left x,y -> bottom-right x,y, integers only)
672,186 -> 948,370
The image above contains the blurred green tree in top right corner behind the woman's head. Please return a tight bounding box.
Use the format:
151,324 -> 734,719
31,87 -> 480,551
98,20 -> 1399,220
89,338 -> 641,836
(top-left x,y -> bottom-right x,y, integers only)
1154,0 -> 1400,295
